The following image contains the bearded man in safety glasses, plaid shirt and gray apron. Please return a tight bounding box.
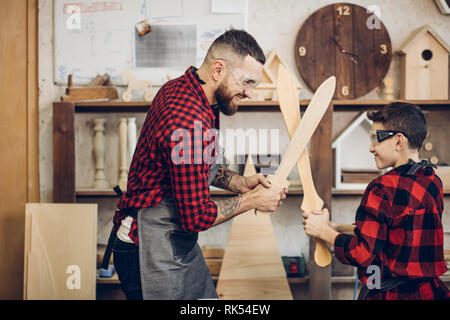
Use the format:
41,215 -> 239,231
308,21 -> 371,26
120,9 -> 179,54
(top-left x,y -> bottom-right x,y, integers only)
113,29 -> 286,300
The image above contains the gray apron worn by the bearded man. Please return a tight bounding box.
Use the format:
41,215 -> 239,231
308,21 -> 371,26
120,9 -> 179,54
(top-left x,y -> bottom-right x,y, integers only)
137,166 -> 221,300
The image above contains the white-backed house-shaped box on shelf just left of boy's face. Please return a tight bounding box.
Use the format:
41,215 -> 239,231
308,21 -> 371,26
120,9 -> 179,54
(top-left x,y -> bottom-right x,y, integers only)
331,112 -> 380,190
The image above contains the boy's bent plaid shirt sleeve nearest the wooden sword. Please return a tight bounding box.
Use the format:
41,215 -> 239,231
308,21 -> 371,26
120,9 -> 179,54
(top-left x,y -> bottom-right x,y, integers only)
334,185 -> 391,268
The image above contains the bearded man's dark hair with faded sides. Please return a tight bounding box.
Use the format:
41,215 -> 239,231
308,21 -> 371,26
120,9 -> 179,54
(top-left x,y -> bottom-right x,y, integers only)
206,29 -> 266,64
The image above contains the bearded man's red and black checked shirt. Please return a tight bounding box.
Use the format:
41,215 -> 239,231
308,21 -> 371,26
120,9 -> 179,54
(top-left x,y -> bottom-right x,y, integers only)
114,67 -> 218,245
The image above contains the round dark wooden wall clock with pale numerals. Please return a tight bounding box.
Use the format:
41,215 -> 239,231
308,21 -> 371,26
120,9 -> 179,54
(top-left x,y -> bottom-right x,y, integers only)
295,3 -> 392,99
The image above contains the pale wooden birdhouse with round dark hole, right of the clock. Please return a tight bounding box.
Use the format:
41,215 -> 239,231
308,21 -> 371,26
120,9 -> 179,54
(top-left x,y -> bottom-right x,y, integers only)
398,25 -> 450,100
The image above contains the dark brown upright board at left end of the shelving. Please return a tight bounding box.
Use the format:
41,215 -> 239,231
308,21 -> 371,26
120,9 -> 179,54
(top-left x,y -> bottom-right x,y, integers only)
53,102 -> 75,203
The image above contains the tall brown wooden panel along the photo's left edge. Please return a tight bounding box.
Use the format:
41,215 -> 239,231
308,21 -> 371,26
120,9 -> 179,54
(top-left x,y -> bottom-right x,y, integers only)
0,0 -> 29,300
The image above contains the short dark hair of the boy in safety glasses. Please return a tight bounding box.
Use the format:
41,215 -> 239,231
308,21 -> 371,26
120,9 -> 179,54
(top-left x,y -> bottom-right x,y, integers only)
367,102 -> 427,150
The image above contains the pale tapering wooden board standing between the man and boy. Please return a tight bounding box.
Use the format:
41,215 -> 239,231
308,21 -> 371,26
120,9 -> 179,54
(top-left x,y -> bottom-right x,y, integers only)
217,156 -> 292,300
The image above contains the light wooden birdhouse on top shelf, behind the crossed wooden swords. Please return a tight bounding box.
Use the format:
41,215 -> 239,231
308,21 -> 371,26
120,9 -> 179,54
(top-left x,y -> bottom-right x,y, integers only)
252,49 -> 302,101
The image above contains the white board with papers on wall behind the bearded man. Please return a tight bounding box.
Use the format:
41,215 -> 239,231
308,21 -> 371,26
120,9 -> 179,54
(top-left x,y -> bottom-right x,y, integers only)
54,0 -> 247,85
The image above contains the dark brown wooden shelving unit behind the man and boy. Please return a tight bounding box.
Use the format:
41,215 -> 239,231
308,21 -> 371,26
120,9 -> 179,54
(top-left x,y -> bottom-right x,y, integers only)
53,100 -> 450,297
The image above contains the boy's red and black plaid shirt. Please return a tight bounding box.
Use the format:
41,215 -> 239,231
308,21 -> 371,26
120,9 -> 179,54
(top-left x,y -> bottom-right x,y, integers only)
334,164 -> 448,300
